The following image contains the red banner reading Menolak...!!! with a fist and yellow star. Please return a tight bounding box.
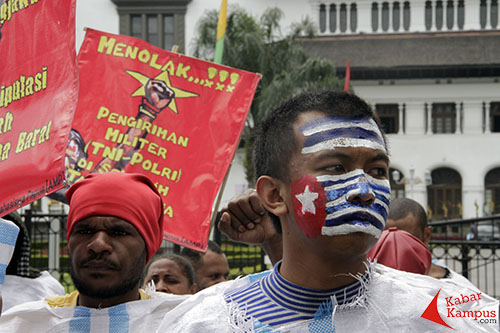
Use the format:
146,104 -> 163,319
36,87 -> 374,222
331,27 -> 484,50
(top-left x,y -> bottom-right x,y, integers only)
67,29 -> 260,250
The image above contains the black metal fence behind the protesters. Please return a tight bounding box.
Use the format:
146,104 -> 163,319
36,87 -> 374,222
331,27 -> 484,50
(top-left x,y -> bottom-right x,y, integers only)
22,210 -> 500,298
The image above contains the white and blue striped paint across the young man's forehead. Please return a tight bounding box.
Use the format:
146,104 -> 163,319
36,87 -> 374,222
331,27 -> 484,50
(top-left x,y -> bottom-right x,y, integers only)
299,116 -> 386,154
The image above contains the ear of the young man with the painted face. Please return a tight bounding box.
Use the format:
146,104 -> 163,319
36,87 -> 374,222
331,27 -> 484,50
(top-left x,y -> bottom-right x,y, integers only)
256,176 -> 288,216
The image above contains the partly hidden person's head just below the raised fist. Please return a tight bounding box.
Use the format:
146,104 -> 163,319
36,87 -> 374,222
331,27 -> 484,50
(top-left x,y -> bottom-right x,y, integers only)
180,240 -> 229,290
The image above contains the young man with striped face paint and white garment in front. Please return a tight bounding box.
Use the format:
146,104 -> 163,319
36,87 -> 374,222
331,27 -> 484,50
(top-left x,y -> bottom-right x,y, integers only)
159,91 -> 498,332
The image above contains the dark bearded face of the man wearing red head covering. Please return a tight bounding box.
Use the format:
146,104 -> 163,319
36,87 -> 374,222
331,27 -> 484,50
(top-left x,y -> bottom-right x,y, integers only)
68,216 -> 147,299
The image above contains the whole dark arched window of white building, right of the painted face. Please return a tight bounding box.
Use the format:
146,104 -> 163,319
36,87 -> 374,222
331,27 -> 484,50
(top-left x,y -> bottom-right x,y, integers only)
427,168 -> 462,220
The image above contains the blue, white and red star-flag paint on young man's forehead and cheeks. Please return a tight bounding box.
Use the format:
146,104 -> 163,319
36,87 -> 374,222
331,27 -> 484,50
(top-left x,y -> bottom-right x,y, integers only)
292,116 -> 391,238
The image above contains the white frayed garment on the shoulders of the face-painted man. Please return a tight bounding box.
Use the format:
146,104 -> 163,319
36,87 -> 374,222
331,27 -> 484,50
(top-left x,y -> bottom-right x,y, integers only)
158,264 -> 499,333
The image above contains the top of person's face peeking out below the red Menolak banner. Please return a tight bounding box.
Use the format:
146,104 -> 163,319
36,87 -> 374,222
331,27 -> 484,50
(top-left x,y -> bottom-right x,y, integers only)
143,254 -> 198,295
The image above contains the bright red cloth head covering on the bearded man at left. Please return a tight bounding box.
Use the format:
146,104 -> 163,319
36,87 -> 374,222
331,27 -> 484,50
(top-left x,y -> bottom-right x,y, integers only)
66,172 -> 163,261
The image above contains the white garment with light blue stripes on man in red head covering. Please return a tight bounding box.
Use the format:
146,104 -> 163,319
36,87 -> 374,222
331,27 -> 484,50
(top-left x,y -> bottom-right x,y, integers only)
0,286 -> 188,333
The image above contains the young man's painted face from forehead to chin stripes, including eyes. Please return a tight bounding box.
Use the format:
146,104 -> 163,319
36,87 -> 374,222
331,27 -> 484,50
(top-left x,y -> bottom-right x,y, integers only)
291,113 -> 390,238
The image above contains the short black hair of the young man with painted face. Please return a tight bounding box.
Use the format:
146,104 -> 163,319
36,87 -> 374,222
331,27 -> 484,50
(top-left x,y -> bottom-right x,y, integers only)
253,90 -> 387,232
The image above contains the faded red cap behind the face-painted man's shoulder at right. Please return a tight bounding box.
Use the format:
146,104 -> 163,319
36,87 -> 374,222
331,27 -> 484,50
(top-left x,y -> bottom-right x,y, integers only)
367,227 -> 432,275
